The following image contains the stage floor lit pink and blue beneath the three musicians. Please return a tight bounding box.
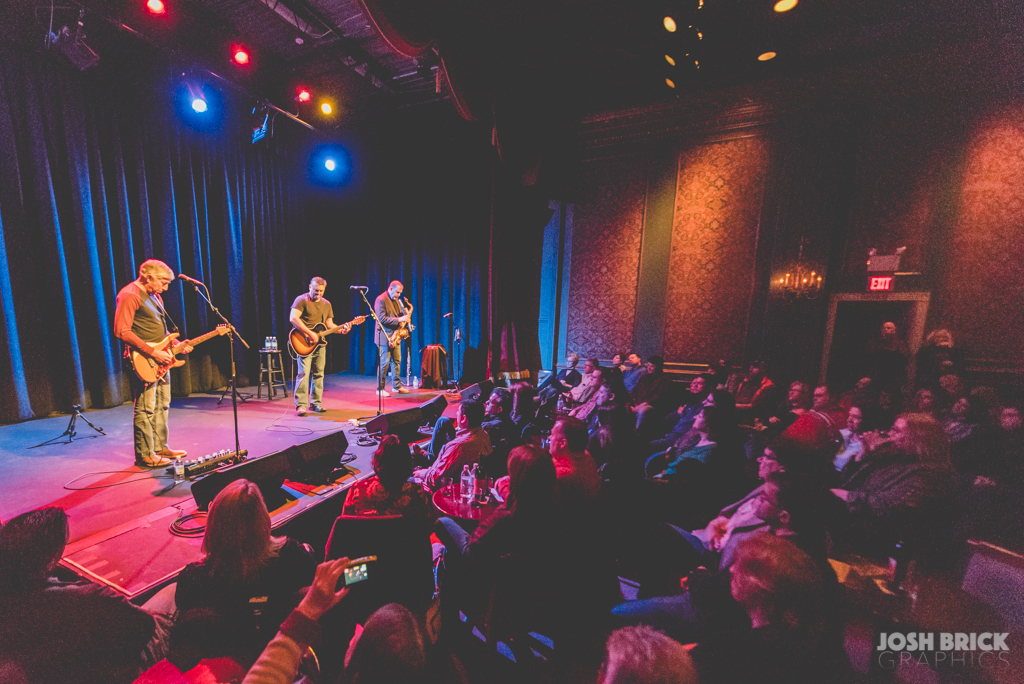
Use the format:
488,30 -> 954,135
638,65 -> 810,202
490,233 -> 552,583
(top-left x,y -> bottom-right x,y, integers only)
0,374 -> 458,596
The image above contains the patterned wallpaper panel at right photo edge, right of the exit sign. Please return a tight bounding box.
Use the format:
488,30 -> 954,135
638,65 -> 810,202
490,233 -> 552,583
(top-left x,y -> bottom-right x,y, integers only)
940,105 -> 1024,362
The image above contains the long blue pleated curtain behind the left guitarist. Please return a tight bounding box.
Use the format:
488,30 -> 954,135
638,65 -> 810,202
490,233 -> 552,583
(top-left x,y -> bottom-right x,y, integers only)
0,42 -> 307,422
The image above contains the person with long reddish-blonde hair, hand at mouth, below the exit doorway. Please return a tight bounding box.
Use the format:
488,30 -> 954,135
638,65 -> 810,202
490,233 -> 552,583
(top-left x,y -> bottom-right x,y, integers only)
831,414 -> 953,558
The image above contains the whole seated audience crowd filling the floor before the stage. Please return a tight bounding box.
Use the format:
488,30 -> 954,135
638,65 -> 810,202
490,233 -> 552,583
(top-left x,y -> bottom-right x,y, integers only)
22,323 -> 1024,684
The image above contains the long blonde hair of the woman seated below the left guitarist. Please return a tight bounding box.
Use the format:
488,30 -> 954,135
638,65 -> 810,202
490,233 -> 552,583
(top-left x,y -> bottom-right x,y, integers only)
203,479 -> 286,582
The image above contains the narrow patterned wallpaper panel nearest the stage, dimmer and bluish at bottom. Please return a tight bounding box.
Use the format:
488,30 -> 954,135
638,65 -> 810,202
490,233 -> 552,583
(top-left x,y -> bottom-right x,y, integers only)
566,157 -> 646,358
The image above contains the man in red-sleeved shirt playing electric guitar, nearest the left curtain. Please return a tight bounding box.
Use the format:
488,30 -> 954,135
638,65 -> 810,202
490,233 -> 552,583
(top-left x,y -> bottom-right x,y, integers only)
114,259 -> 193,468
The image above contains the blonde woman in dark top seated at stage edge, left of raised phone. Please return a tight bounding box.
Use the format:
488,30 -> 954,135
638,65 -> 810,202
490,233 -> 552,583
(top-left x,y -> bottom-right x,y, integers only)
174,479 -> 316,661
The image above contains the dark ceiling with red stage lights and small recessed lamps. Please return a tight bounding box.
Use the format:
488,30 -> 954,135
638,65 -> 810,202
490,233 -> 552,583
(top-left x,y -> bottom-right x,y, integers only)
16,0 -> 1024,125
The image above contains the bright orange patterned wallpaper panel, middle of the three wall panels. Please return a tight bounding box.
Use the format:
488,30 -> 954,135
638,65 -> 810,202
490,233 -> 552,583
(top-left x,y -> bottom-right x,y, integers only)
664,138 -> 768,361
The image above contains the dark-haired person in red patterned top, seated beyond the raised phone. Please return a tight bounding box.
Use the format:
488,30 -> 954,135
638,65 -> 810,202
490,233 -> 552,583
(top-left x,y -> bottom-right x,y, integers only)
342,434 -> 437,523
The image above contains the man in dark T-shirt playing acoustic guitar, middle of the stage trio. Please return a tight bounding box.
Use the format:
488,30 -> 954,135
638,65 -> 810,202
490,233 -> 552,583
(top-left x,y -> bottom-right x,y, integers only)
288,275 -> 352,416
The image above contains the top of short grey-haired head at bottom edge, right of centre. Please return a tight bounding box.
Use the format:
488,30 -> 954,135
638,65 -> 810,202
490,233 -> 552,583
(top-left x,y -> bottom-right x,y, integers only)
597,625 -> 697,684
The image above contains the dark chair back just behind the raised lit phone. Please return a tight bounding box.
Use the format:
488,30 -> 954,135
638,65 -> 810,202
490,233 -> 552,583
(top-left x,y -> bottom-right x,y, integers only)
326,515 -> 434,615
